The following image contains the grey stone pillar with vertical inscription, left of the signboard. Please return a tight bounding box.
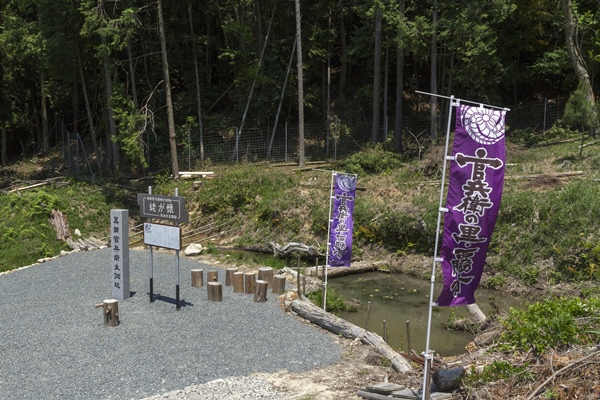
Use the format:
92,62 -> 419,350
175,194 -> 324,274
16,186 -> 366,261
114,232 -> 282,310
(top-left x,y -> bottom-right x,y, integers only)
110,210 -> 131,300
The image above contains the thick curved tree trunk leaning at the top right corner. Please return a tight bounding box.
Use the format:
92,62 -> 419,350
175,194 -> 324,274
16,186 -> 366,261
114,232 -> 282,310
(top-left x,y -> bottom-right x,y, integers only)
561,0 -> 600,137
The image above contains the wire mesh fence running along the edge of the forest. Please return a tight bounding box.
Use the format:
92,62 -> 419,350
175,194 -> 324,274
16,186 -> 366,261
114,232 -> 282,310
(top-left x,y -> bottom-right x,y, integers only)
56,99 -> 566,175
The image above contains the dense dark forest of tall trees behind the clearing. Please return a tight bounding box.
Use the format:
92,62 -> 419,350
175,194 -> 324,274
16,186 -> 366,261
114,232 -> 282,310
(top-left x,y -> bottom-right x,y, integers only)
0,0 -> 600,177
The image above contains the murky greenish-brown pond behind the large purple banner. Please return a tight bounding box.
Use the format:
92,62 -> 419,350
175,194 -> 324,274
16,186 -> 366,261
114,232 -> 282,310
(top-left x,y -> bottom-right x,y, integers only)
327,272 -> 523,356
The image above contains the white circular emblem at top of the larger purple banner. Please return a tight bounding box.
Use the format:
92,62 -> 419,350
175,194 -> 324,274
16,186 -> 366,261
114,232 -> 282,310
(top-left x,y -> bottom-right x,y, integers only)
462,107 -> 504,145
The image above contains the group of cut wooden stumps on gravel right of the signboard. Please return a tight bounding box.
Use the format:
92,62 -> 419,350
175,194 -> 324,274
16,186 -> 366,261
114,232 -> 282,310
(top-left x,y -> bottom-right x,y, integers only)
191,267 -> 285,302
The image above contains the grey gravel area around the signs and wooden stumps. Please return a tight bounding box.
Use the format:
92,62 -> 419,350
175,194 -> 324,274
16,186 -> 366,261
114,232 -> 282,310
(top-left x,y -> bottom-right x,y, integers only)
0,249 -> 341,400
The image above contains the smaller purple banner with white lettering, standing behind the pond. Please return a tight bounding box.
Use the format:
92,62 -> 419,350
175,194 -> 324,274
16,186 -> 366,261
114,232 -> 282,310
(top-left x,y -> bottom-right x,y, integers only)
329,173 -> 357,267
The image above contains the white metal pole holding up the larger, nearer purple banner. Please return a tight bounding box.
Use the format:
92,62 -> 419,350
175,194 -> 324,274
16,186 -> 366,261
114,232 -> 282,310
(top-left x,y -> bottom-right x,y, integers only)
422,96 -> 460,400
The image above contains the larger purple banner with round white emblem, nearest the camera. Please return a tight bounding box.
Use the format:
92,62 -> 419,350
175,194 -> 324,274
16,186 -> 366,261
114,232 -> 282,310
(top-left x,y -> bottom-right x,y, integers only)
437,105 -> 506,306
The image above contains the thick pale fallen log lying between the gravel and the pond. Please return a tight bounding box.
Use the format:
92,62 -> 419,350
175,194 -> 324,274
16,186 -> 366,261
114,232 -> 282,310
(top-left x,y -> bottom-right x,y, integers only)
290,299 -> 412,373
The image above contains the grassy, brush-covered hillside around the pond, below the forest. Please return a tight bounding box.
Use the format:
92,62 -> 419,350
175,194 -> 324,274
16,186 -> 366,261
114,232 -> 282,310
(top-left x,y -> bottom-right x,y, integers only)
0,137 -> 600,398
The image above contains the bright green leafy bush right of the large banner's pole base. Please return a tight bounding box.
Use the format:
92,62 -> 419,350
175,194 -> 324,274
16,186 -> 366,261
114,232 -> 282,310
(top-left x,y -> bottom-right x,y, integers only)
500,297 -> 600,355
